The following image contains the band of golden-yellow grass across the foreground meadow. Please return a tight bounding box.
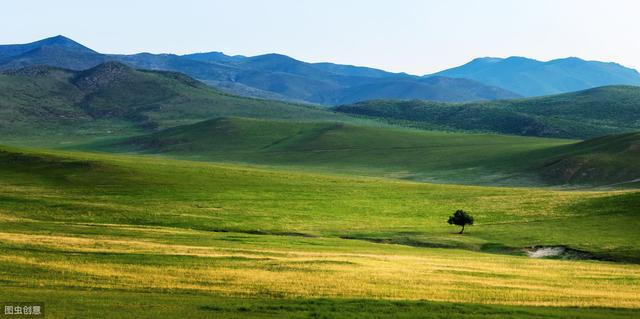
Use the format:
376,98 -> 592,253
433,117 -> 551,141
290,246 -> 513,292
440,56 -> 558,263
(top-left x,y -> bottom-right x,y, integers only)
0,229 -> 640,308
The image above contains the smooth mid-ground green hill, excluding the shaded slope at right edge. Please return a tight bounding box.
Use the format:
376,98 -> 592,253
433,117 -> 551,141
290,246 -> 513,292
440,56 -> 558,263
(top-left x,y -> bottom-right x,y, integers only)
88,118 -> 571,185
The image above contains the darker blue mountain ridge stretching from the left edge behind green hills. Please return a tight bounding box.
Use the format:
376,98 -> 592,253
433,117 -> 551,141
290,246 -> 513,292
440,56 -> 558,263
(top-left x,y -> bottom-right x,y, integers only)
0,36 -> 519,104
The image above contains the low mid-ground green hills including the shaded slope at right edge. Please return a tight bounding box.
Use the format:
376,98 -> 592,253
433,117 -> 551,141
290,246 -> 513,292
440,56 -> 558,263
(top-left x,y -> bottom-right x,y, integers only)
92,118 -> 640,186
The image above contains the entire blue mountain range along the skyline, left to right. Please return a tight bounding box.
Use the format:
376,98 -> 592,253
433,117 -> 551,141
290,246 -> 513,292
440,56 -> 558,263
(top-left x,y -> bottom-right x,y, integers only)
0,36 -> 640,105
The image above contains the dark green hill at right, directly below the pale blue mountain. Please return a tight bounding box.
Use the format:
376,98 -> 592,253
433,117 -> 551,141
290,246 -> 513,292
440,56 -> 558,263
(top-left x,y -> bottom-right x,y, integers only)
335,86 -> 640,138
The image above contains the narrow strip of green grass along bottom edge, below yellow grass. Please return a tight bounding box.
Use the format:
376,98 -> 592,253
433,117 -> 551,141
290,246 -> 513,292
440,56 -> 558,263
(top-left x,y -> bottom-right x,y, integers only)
6,289 -> 638,319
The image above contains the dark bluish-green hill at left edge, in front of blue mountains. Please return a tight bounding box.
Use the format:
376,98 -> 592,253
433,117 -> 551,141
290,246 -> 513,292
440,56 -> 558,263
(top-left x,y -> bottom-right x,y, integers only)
0,62 -> 346,143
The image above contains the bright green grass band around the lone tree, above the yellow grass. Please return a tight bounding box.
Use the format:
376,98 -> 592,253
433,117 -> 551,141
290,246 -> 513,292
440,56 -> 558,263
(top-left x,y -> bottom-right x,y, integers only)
0,146 -> 640,259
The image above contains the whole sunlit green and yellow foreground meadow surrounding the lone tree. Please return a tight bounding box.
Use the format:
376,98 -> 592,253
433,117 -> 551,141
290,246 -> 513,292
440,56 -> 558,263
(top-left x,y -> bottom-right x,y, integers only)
0,149 -> 640,318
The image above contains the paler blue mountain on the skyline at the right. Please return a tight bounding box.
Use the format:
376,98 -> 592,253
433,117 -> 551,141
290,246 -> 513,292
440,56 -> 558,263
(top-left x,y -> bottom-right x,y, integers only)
434,57 -> 640,96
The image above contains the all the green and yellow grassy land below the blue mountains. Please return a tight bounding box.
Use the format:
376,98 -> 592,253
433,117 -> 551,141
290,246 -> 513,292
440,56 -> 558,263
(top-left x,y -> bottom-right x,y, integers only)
0,48 -> 640,318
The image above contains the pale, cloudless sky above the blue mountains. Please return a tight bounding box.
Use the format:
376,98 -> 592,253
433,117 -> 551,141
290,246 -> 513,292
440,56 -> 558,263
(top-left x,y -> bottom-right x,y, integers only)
0,0 -> 640,75
